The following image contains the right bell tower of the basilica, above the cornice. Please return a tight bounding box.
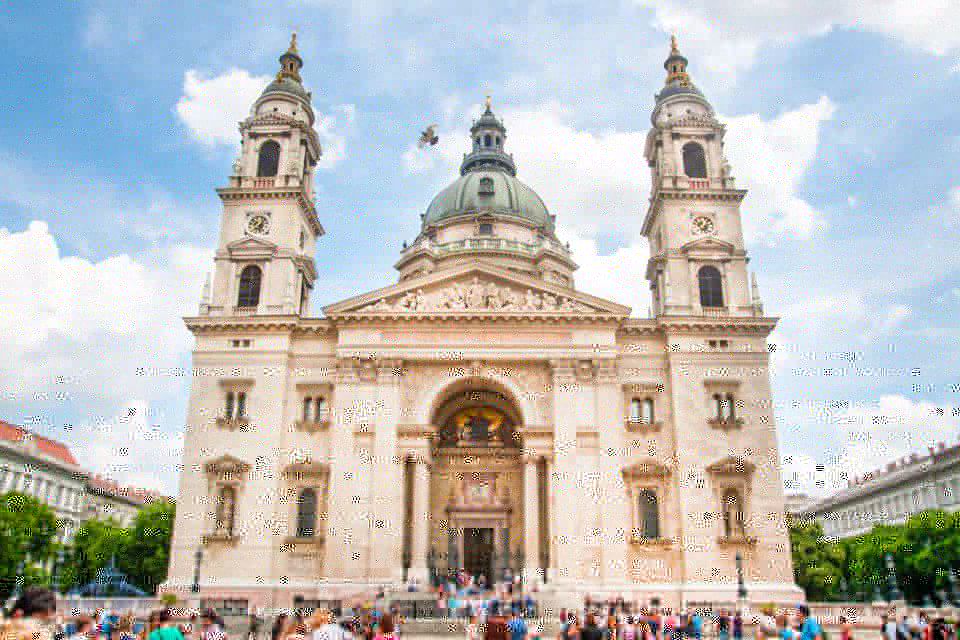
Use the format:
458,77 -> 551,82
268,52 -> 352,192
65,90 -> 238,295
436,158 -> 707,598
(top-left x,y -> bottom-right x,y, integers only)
642,38 -> 763,316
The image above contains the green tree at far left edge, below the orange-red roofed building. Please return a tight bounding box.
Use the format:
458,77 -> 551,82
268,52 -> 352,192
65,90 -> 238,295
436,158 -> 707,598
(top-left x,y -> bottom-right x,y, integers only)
0,492 -> 58,600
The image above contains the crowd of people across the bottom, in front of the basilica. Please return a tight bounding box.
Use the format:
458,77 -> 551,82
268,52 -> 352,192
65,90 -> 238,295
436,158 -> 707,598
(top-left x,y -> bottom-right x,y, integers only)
0,575 -> 957,640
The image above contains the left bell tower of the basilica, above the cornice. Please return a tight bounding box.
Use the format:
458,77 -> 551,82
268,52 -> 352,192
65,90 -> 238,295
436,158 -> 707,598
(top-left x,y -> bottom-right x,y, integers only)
200,34 -> 324,316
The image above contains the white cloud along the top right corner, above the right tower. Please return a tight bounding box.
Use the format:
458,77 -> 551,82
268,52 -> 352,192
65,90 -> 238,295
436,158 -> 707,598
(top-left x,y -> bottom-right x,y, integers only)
637,0 -> 960,72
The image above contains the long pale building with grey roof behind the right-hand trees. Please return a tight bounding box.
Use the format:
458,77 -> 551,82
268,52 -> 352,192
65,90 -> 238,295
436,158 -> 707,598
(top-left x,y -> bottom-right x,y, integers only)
801,442 -> 960,538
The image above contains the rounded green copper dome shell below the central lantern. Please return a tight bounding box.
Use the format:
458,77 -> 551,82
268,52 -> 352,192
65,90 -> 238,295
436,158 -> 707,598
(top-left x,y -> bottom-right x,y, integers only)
423,167 -> 553,231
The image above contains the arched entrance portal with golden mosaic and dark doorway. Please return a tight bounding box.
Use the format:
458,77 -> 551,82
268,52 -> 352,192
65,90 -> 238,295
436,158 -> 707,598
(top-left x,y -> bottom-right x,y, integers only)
430,381 -> 523,583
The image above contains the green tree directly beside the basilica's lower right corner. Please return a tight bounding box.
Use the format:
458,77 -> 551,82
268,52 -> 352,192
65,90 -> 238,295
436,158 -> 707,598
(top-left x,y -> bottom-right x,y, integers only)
790,522 -> 846,601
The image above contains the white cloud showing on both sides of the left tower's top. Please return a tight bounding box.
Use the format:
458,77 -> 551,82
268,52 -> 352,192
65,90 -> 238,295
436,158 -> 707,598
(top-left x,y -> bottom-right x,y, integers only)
176,68 -> 356,169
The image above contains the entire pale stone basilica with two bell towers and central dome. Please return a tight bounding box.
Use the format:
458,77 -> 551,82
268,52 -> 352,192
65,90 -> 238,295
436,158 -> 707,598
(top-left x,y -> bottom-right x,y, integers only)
163,35 -> 803,608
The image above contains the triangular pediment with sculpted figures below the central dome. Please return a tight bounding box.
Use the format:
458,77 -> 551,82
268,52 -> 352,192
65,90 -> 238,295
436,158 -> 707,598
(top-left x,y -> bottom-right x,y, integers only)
323,264 -> 630,317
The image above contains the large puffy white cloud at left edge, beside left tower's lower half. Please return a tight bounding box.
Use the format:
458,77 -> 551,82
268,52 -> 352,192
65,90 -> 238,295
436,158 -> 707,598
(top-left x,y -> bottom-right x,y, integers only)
0,221 -> 210,402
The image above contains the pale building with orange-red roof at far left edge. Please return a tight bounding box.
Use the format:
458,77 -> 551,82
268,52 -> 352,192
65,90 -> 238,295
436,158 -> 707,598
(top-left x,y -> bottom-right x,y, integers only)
0,421 -> 86,541
